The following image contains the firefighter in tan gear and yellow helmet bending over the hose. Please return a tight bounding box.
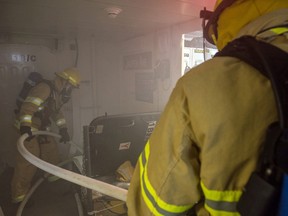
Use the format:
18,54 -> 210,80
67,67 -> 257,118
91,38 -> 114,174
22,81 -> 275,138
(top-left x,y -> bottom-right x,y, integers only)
11,68 -> 80,203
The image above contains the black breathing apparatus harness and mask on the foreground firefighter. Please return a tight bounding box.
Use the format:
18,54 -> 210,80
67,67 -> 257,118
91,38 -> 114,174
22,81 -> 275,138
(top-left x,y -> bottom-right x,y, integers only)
200,0 -> 288,216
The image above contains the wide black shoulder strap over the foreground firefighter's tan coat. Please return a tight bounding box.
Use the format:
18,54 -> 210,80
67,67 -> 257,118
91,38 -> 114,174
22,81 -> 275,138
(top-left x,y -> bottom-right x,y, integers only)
215,36 -> 288,128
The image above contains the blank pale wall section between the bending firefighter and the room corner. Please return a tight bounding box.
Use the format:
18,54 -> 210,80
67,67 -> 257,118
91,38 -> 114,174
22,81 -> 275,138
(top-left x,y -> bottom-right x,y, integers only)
73,36 -> 121,147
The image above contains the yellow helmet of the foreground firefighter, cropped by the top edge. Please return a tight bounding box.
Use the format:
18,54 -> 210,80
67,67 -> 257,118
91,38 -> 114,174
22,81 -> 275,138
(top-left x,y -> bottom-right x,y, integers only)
204,0 -> 288,50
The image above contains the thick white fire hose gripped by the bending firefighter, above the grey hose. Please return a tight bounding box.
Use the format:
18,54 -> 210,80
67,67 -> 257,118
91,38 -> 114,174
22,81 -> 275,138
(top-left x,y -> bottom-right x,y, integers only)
17,131 -> 127,202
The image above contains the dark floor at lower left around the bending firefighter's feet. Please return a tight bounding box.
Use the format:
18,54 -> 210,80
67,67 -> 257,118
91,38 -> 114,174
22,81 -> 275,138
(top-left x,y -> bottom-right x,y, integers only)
0,164 -> 83,216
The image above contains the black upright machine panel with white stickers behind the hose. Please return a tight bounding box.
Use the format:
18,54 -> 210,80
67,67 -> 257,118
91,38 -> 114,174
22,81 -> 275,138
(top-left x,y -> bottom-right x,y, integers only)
82,112 -> 160,213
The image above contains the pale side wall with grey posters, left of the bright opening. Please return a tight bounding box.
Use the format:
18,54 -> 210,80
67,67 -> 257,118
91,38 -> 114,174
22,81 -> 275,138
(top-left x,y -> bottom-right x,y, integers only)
120,20 -> 201,113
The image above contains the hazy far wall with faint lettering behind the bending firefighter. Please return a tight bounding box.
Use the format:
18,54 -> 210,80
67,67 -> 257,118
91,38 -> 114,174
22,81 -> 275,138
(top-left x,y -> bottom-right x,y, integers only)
0,37 -> 75,165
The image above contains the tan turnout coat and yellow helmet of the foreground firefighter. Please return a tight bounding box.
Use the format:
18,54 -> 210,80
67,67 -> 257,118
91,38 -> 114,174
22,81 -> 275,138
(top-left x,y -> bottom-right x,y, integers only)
127,0 -> 288,216
